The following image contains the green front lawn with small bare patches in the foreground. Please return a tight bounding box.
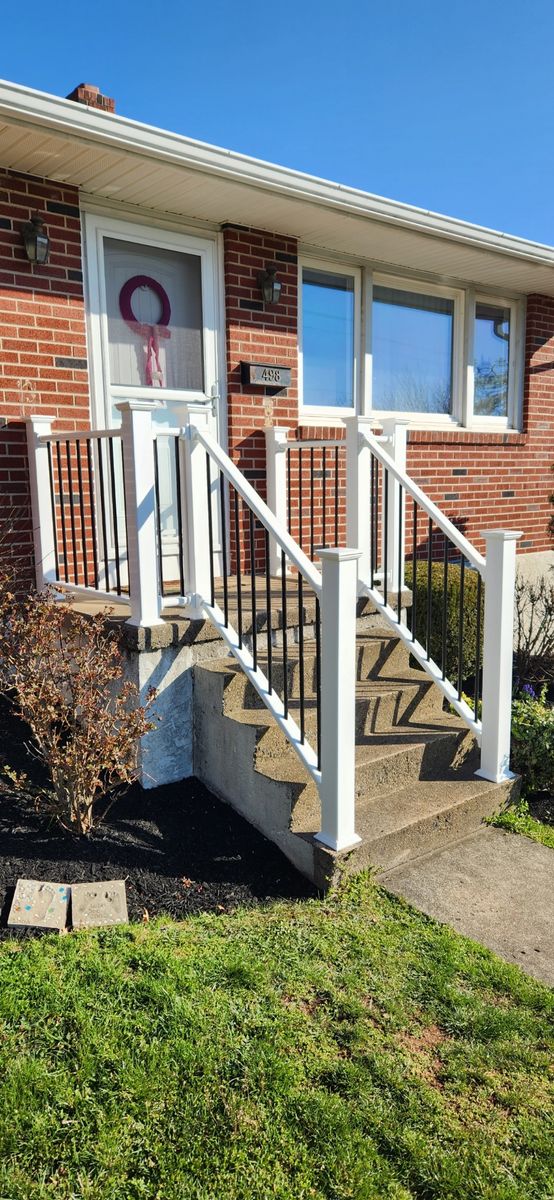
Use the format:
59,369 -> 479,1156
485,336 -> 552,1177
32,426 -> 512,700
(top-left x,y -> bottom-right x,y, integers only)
0,877 -> 554,1200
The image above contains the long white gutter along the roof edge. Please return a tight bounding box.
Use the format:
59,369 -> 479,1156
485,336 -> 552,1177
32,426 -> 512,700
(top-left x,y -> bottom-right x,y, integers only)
0,80 -> 554,266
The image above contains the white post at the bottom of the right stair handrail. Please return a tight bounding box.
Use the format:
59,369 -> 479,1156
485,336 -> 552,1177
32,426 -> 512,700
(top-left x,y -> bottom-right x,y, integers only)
477,529 -> 522,784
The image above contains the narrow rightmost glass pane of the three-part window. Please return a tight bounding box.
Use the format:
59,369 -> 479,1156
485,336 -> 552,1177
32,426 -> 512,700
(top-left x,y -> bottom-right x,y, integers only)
474,301 -> 510,416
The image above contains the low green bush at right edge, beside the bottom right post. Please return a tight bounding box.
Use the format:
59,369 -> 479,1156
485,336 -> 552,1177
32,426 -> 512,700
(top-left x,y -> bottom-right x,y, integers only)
512,688 -> 554,792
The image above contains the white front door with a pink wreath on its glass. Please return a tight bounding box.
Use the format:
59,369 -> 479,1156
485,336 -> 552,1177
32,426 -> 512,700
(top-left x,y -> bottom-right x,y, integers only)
85,214 -> 219,587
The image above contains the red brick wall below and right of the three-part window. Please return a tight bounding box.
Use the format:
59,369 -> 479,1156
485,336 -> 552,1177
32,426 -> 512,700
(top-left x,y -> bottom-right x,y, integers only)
408,295 -> 554,553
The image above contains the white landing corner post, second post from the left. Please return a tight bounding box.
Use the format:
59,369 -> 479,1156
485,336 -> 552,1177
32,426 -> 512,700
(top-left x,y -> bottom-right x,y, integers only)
115,400 -> 163,626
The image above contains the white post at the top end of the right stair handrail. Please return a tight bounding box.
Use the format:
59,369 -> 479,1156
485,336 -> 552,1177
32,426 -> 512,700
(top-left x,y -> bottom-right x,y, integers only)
345,416 -> 372,580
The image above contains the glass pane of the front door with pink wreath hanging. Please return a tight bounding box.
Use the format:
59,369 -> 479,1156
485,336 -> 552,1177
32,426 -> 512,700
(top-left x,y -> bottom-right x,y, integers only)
104,238 -> 204,391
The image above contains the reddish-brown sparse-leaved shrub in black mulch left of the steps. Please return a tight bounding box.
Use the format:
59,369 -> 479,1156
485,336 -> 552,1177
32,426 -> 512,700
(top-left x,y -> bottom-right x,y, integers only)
0,592 -> 153,834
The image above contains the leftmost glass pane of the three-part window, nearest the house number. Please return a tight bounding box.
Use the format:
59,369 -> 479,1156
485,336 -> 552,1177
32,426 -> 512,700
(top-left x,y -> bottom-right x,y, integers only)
302,268 -> 355,408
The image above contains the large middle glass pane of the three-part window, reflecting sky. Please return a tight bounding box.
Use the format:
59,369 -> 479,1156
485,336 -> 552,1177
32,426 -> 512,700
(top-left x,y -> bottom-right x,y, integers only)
373,287 -> 454,414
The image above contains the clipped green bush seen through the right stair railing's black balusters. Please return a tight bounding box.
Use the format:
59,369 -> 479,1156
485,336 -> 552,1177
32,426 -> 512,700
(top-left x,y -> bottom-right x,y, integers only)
405,562 -> 484,680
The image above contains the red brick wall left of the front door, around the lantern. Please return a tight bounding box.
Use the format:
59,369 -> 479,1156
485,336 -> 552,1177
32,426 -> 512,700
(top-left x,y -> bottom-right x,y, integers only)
0,172 -> 90,585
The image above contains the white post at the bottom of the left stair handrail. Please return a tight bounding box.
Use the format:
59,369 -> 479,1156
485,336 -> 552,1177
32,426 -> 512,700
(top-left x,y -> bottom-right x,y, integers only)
317,550 -> 360,851
